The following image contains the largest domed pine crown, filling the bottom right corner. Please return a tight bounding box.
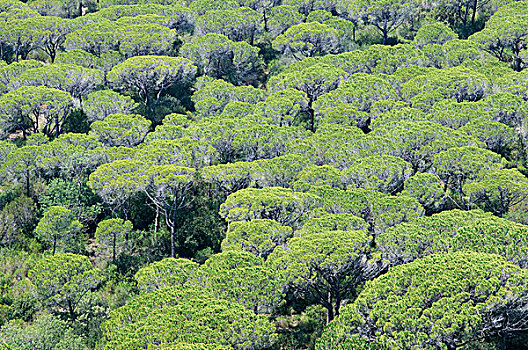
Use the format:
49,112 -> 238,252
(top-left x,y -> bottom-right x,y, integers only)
316,252 -> 528,350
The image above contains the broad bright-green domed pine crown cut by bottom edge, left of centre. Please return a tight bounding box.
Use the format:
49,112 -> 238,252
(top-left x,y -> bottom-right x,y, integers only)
103,286 -> 276,349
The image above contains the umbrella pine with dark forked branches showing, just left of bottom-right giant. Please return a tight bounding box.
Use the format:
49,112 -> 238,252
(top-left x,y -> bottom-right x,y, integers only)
268,230 -> 370,323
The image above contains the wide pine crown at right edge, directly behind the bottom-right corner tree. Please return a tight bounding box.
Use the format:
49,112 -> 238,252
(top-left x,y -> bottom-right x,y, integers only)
376,210 -> 528,268
